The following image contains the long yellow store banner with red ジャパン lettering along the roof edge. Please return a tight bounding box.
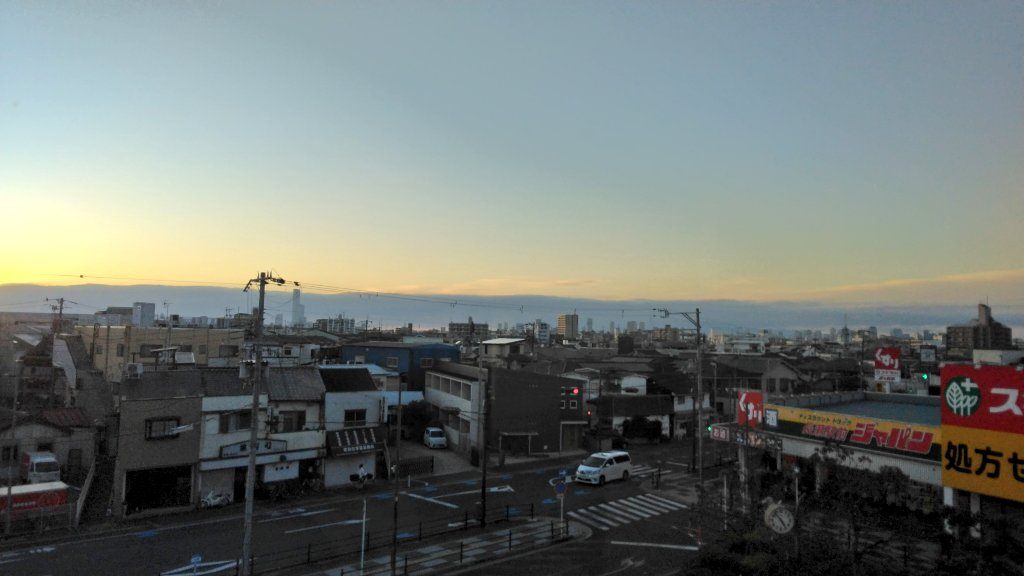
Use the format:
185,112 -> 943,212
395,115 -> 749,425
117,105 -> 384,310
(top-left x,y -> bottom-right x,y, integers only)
765,405 -> 942,462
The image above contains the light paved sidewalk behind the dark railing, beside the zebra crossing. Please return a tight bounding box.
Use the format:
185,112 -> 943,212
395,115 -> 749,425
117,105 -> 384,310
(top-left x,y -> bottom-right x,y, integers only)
296,518 -> 591,576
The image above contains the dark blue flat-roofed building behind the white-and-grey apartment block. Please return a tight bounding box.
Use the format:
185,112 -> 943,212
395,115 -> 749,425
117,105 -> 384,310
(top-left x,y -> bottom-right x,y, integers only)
341,341 -> 460,390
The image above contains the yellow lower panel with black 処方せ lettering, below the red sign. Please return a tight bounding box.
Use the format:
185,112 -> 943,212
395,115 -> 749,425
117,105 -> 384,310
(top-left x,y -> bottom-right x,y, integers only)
942,425 -> 1024,502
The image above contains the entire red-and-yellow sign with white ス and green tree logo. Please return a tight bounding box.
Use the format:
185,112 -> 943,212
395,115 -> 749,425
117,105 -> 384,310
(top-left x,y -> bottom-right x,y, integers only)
942,364 -> 1024,502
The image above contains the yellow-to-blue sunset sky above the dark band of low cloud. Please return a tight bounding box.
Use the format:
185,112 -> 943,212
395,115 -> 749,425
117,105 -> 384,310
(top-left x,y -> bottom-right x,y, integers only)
0,1 -> 1024,306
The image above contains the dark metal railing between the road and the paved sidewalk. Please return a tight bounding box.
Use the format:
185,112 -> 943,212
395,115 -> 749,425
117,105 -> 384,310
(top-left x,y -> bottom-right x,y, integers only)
241,503 -> 567,574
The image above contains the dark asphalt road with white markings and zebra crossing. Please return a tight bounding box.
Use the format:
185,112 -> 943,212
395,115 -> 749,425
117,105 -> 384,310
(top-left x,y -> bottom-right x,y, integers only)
0,444 -> 720,576
